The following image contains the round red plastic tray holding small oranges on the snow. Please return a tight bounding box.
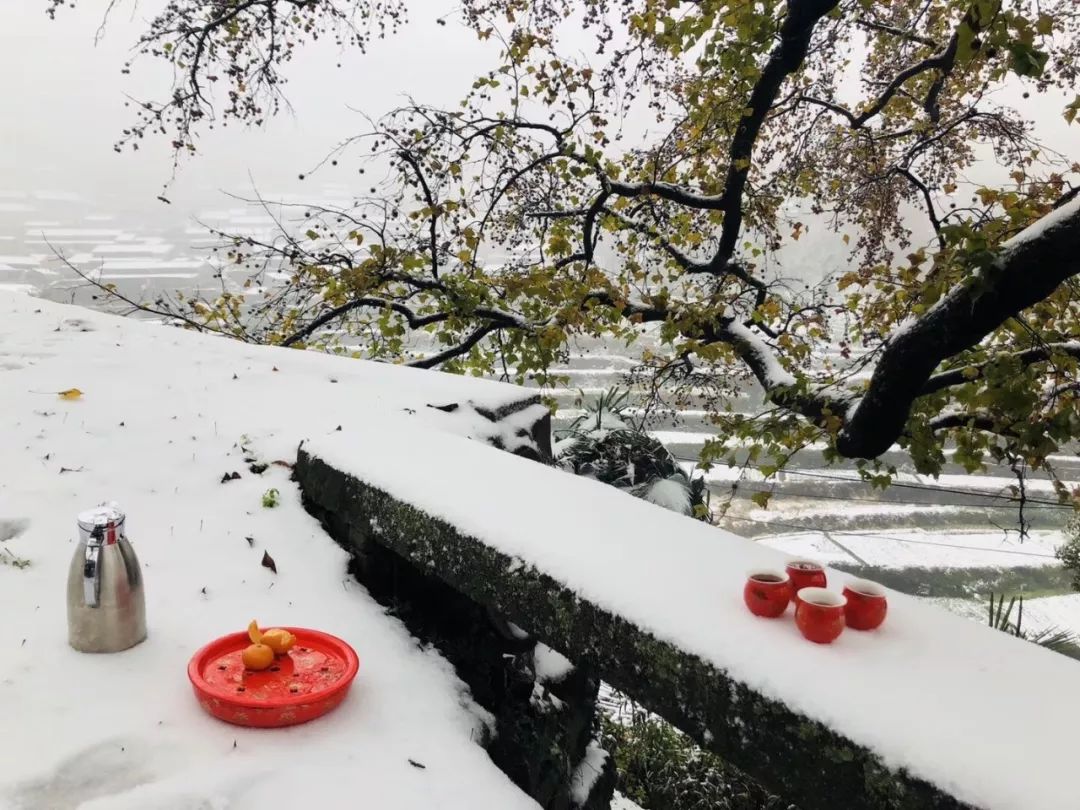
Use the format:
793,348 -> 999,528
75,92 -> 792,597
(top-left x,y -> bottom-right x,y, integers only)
188,627 -> 360,728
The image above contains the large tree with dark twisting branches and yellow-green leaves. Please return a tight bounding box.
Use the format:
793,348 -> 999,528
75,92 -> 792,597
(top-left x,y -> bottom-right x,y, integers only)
54,0 -> 1080,497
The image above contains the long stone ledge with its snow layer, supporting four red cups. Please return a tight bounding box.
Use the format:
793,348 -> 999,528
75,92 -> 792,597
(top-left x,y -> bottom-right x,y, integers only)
296,432 -> 1080,810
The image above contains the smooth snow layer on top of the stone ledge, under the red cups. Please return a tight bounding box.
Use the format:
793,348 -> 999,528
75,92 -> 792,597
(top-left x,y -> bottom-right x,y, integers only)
306,414 -> 1080,810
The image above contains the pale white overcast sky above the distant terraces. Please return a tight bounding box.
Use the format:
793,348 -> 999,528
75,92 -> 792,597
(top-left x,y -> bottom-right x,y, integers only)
0,0 -> 1080,231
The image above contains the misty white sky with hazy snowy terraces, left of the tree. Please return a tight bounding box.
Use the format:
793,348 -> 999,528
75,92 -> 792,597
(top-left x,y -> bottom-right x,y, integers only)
0,0 -> 1076,299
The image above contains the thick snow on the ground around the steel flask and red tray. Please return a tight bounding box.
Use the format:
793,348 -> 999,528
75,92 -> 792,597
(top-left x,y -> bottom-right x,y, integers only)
0,293 -> 537,810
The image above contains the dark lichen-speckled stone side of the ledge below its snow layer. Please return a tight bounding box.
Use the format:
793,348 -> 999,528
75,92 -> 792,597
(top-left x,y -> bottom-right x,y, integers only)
296,447 -> 969,810
